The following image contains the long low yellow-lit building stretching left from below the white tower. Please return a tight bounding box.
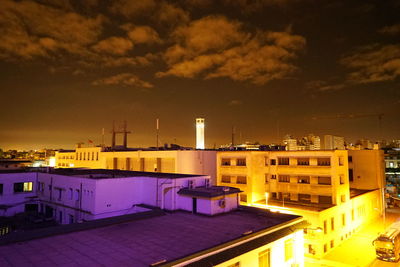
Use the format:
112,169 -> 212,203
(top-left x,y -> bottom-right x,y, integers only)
55,147 -> 217,184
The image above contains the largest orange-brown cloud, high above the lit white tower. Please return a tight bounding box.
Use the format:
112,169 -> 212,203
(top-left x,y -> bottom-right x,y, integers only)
156,16 -> 306,85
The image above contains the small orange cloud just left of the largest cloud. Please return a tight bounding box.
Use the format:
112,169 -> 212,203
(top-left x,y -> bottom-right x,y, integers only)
123,24 -> 162,44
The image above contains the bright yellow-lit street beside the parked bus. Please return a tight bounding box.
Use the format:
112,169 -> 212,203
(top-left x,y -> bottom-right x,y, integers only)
305,209 -> 400,267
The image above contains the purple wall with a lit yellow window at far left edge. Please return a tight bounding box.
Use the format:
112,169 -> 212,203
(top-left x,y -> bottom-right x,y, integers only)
0,173 -> 37,216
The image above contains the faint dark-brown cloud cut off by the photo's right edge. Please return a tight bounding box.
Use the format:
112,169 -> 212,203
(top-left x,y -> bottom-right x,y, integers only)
340,44 -> 400,84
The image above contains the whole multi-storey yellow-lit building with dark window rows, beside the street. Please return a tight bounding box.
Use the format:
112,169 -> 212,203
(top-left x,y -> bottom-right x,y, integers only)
217,150 -> 384,258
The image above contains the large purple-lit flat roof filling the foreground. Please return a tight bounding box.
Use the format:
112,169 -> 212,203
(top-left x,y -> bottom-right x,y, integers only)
0,209 -> 301,266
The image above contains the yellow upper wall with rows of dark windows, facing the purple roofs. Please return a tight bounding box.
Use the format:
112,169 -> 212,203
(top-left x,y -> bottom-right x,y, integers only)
217,150 -> 349,207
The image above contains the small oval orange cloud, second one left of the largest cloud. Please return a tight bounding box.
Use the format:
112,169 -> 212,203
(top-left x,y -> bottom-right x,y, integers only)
93,37 -> 133,55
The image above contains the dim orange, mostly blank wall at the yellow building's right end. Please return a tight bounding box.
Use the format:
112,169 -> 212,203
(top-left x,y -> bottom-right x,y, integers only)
349,150 -> 385,190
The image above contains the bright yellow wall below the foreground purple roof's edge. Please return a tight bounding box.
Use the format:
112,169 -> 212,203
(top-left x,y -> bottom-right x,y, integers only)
216,230 -> 304,267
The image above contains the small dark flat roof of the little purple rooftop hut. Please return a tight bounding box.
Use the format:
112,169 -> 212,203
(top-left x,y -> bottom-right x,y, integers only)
178,186 -> 243,198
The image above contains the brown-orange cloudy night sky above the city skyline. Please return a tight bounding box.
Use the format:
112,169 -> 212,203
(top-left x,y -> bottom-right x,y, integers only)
0,0 -> 400,150
